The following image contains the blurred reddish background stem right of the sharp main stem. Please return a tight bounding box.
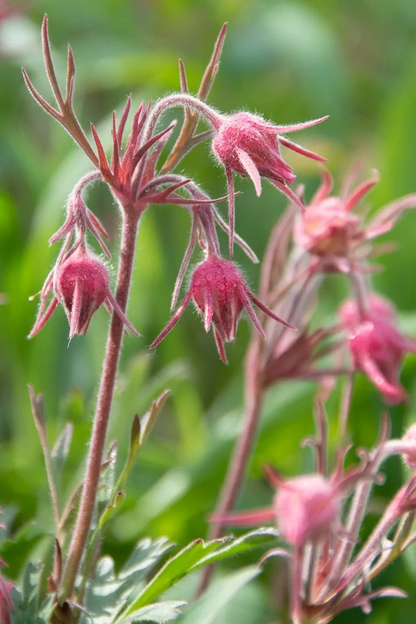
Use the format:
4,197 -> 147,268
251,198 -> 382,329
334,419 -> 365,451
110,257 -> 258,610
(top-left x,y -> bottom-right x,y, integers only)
198,335 -> 262,596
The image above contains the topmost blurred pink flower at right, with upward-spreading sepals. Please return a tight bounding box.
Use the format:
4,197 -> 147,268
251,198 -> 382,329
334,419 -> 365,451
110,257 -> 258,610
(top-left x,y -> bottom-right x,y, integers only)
295,170 -> 416,272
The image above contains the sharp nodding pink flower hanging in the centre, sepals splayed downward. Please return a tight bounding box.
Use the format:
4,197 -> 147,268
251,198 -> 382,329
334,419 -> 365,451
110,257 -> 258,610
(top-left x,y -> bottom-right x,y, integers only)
150,255 -> 291,362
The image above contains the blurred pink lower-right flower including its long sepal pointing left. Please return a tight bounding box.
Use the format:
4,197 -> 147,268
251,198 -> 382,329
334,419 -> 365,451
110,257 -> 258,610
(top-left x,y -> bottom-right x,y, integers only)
211,467 -> 342,546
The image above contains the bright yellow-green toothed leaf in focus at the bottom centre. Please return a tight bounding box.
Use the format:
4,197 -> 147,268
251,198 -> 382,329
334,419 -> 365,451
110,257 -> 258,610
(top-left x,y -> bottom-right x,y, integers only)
117,538 -> 230,622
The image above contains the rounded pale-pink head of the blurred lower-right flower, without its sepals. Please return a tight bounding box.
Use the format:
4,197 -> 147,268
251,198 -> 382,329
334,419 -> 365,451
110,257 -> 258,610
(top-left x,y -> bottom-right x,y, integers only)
273,474 -> 340,546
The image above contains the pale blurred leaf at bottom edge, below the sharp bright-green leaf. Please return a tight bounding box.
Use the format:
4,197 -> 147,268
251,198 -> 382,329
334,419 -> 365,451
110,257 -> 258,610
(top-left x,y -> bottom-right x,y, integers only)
181,566 -> 261,624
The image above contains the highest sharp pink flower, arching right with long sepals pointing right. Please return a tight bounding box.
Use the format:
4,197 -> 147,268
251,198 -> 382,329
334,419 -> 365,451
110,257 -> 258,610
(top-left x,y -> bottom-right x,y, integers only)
212,112 -> 328,253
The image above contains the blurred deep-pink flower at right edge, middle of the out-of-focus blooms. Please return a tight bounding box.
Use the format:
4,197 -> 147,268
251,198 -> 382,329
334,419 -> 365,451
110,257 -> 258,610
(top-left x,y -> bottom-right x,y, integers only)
339,296 -> 416,405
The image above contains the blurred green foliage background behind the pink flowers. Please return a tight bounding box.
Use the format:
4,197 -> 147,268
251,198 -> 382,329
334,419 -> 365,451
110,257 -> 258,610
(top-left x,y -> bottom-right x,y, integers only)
0,0 -> 416,624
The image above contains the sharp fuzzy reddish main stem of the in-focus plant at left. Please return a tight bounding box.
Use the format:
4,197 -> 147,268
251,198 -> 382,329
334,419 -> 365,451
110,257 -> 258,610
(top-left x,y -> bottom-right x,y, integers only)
59,210 -> 138,604
